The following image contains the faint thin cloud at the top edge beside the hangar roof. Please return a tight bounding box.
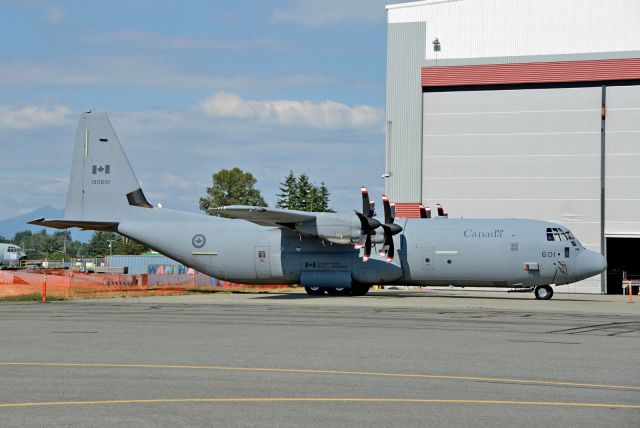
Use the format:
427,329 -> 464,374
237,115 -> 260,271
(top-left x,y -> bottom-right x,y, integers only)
271,0 -> 390,27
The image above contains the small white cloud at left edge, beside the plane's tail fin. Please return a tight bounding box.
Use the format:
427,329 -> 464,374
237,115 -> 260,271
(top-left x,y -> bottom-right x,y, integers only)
0,105 -> 72,129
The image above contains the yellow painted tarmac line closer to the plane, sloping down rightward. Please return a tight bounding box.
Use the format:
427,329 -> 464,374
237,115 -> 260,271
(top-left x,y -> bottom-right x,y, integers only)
0,362 -> 640,391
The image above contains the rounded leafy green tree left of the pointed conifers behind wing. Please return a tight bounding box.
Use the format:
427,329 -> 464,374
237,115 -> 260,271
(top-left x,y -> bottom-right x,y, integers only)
200,167 -> 267,216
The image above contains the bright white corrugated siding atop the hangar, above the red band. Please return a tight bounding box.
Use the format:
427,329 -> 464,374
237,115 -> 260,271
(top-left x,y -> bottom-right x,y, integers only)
388,0 -> 640,65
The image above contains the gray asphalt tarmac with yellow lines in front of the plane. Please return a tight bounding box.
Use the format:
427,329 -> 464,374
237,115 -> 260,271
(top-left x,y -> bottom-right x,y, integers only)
0,290 -> 640,427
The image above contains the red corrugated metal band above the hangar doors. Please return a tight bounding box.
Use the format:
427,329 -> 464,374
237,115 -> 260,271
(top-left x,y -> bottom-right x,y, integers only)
422,58 -> 640,88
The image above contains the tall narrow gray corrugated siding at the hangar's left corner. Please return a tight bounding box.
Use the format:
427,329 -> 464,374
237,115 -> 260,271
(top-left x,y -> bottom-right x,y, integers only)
385,23 -> 425,202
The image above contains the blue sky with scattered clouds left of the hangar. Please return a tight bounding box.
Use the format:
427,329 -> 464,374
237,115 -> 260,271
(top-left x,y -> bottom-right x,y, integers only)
0,0 -> 386,219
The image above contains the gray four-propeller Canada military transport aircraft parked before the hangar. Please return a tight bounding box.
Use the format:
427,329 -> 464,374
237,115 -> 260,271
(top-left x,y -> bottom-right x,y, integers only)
30,111 -> 606,299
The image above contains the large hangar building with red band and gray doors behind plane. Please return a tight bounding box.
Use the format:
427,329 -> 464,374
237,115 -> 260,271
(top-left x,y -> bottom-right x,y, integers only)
385,0 -> 640,293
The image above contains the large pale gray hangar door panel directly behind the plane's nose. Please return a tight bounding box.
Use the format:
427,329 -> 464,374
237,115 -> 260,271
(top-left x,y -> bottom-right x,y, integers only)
422,87 -> 602,292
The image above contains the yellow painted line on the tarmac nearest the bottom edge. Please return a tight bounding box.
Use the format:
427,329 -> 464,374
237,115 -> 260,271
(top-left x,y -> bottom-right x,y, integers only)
0,397 -> 640,409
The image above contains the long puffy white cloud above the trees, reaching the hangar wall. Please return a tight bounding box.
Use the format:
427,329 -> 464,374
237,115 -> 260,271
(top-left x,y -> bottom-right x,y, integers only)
200,92 -> 384,129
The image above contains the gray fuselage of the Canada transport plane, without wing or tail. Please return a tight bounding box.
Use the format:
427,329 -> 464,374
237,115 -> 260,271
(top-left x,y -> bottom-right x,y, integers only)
118,208 -> 604,287
